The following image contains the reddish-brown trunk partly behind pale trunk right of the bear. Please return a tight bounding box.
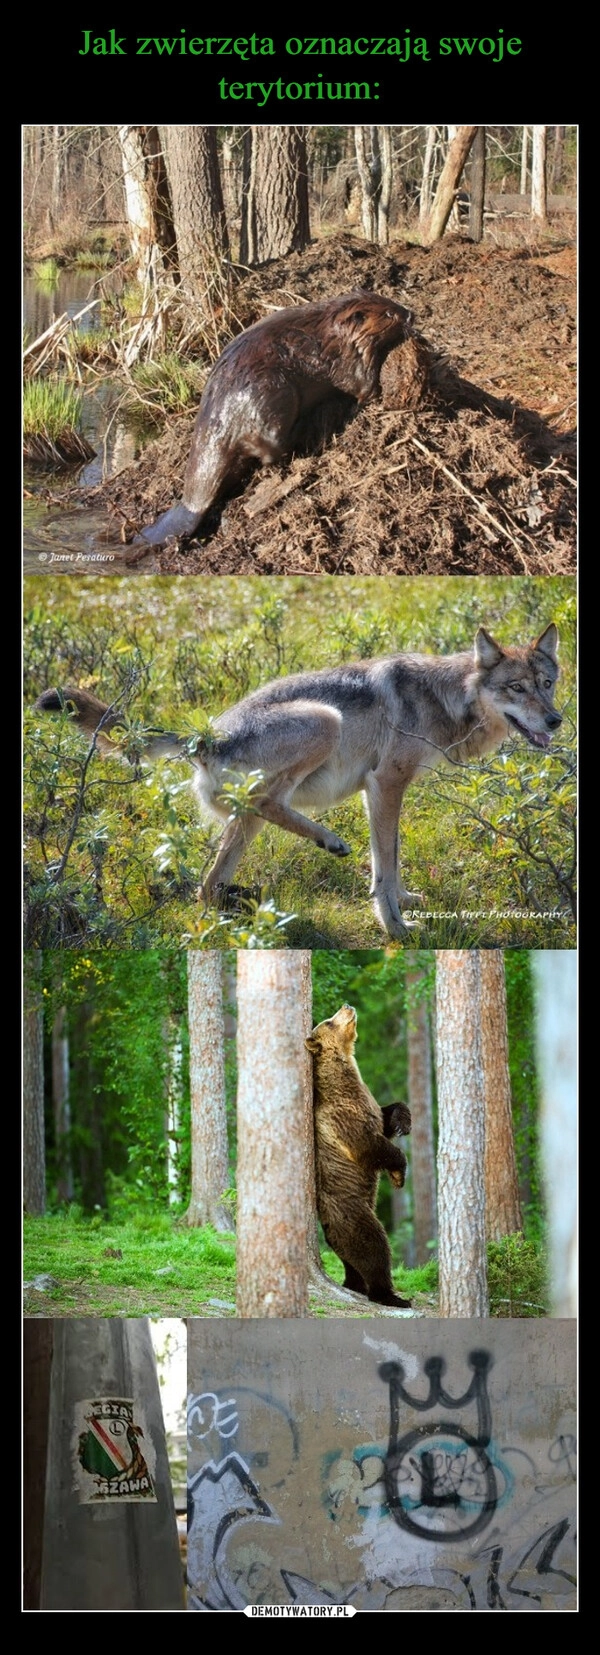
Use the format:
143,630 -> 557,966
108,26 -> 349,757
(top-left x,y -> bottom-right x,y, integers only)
479,948 -> 522,1241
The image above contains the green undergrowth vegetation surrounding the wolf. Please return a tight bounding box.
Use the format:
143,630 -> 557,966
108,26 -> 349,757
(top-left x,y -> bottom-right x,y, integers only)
25,576 -> 575,948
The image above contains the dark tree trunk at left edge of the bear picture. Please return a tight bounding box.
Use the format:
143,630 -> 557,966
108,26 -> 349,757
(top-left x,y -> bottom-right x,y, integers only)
23,950 -> 46,1215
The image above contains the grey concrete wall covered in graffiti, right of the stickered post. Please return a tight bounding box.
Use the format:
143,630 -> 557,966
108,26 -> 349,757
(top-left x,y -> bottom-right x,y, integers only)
188,1319 -> 575,1614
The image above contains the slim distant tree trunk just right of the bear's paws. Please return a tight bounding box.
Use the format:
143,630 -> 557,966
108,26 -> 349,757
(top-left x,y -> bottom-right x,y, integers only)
407,965 -> 438,1264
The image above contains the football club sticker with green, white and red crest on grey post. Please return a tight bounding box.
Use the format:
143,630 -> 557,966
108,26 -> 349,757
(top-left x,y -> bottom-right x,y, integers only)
73,1397 -> 157,1506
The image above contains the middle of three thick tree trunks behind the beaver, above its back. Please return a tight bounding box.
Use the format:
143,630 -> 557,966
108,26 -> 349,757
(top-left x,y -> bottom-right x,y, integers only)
160,126 -> 230,301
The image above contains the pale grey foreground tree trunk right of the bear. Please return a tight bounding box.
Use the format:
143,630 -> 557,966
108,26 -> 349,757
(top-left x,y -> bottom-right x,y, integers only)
436,950 -> 489,1316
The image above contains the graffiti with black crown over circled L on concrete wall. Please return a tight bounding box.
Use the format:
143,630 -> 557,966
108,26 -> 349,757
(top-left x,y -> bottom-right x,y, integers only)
188,1349 -> 577,1612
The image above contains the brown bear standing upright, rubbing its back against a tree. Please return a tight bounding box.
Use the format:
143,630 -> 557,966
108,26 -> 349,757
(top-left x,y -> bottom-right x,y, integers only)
306,1006 -> 410,1311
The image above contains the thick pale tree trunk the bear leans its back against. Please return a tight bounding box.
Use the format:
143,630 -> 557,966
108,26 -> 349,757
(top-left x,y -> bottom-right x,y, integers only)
236,950 -> 312,1317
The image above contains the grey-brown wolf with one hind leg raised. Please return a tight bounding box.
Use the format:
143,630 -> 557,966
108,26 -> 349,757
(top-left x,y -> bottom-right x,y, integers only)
36,622 -> 562,942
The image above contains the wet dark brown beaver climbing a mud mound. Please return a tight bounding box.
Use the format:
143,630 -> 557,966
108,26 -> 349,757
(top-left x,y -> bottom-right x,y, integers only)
134,293 -> 412,554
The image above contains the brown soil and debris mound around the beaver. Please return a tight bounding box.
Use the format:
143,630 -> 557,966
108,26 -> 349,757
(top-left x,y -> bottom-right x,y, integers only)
90,233 -> 575,576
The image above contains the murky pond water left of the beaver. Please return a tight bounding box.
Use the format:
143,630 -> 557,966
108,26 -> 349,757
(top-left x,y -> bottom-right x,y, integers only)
23,270 -> 157,574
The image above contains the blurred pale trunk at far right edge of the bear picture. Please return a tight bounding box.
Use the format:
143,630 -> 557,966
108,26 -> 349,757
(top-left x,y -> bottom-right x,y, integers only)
532,950 -> 577,1316
